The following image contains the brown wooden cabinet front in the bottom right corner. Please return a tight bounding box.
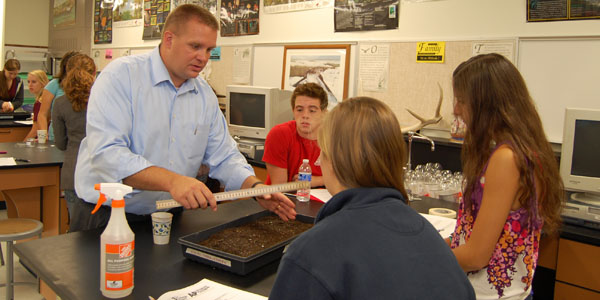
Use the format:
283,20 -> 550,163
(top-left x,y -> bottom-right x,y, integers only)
554,238 -> 600,300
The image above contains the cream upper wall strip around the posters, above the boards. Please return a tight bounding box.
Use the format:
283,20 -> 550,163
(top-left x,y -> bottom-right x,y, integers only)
97,0 -> 600,48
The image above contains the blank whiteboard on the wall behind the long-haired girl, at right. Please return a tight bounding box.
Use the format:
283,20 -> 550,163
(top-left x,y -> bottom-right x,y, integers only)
517,36 -> 600,143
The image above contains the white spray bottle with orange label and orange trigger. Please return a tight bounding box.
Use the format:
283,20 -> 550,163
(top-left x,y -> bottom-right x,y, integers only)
92,183 -> 135,298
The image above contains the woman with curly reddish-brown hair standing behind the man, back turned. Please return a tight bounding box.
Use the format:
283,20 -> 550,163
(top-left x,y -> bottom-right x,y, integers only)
52,54 -> 96,231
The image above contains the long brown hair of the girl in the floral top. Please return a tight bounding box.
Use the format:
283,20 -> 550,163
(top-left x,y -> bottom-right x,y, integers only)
452,54 -> 564,233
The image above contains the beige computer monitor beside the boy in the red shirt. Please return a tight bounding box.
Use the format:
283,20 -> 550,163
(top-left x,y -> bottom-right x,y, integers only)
225,85 -> 294,139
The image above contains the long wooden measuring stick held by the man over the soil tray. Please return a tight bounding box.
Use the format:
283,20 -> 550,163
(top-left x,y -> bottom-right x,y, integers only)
156,181 -> 310,209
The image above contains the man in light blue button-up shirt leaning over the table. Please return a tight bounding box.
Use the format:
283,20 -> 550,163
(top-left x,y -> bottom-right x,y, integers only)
70,5 -> 296,231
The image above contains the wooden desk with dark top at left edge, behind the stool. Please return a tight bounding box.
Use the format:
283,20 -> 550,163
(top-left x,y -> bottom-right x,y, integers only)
0,143 -> 64,236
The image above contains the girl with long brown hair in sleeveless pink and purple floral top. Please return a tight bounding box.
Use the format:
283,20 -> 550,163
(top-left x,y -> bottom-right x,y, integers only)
448,54 -> 564,299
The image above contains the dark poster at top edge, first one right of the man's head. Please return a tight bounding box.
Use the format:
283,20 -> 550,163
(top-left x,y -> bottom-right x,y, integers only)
220,0 -> 259,36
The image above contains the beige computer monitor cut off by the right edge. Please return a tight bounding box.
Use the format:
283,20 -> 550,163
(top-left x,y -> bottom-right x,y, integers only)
560,108 -> 600,205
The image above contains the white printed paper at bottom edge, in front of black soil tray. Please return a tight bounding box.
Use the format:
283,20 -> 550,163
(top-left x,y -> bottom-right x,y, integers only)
158,279 -> 267,300
